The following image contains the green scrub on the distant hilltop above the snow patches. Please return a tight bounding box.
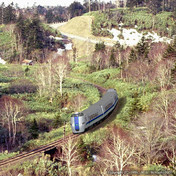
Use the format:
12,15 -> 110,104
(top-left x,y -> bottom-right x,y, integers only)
85,8 -> 176,37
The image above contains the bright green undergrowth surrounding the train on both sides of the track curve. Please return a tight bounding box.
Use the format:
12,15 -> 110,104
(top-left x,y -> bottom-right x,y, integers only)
0,62 -> 156,158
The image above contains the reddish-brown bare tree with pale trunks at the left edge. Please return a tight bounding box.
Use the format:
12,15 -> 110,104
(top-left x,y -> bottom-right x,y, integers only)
0,96 -> 24,145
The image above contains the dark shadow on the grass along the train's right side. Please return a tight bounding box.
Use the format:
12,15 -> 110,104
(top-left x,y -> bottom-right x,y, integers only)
86,97 -> 126,133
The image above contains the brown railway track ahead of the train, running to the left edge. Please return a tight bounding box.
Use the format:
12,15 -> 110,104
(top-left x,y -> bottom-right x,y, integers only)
0,134 -> 79,172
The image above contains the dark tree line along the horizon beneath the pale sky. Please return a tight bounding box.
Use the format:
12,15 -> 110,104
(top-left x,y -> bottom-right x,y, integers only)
0,0 -> 176,24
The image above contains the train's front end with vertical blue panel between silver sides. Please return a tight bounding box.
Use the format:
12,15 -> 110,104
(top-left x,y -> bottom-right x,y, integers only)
71,112 -> 86,133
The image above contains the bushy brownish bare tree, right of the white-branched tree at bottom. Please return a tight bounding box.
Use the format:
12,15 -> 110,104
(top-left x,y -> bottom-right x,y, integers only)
133,112 -> 164,164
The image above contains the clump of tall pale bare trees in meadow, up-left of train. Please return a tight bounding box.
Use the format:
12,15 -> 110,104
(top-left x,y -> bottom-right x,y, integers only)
36,54 -> 68,99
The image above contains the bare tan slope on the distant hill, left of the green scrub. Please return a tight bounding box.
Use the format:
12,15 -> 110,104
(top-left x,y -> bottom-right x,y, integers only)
57,16 -> 115,57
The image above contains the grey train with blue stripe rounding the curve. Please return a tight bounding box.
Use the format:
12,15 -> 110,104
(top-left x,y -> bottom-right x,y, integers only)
71,89 -> 118,134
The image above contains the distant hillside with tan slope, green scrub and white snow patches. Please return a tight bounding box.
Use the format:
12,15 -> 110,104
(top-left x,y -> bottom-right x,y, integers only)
56,9 -> 175,57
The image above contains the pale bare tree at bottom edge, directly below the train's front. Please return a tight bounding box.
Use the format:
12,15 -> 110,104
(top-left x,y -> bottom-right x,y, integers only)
59,138 -> 79,176
